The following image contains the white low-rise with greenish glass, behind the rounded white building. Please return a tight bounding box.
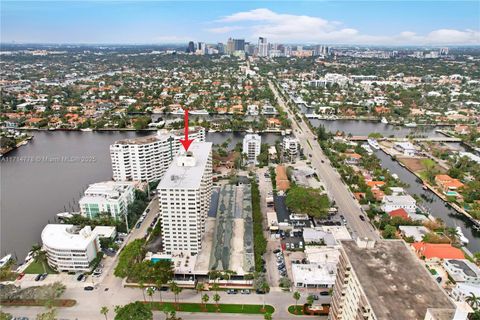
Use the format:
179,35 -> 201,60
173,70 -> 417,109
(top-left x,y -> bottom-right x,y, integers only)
79,181 -> 135,219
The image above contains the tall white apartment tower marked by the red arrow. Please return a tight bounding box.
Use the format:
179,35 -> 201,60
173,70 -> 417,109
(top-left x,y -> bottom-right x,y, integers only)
157,142 -> 212,254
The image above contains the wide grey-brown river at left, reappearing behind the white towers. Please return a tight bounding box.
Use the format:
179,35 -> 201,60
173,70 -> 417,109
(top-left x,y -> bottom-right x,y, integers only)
0,131 -> 281,261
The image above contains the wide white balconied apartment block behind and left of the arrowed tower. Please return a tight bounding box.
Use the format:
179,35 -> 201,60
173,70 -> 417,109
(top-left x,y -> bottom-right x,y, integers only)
110,127 -> 205,182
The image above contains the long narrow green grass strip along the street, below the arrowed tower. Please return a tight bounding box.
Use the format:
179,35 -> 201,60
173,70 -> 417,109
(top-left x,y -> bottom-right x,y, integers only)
148,302 -> 275,314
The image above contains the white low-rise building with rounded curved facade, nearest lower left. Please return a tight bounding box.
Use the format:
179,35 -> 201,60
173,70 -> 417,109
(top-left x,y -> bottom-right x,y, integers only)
41,224 -> 111,271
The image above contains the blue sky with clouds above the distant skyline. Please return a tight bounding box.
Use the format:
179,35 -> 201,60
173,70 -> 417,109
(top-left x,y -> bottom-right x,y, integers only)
0,0 -> 480,45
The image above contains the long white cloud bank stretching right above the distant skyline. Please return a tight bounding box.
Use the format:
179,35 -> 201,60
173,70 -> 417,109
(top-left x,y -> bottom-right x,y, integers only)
207,8 -> 480,45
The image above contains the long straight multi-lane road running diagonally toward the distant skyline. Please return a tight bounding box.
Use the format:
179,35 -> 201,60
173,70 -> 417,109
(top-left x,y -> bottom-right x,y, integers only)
269,81 -> 380,239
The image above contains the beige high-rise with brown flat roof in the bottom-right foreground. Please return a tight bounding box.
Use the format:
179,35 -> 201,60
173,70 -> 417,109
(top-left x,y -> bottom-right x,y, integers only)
329,238 -> 466,320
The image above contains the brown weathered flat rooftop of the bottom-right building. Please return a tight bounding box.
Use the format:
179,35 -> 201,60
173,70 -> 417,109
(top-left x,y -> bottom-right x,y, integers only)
341,240 -> 455,320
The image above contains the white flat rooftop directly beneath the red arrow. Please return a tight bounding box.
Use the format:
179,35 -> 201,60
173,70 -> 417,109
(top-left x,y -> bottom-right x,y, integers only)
157,141 -> 212,190
